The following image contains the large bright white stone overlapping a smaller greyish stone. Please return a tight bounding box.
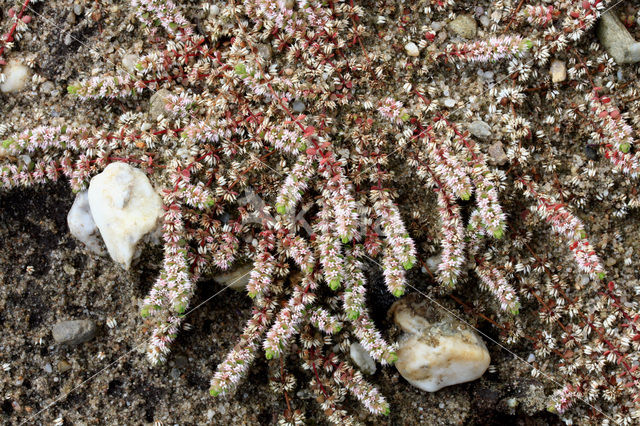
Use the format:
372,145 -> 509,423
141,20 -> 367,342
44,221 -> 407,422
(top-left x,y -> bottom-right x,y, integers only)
89,163 -> 163,269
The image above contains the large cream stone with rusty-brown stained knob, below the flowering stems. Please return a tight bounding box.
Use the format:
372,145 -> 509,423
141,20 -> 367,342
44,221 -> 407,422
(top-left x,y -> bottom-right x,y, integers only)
390,293 -> 491,392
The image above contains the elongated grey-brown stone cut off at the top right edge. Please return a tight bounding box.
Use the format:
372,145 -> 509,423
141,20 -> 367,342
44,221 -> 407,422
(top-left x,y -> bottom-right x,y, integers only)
597,10 -> 640,64
